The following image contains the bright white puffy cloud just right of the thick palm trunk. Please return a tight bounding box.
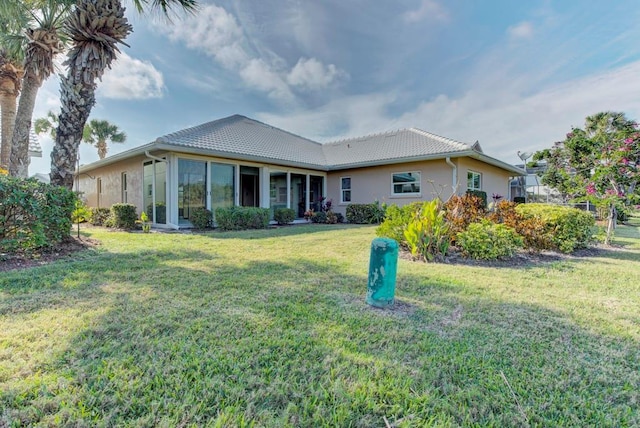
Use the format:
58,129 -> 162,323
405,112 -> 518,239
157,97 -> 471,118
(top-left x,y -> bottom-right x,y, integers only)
98,52 -> 164,100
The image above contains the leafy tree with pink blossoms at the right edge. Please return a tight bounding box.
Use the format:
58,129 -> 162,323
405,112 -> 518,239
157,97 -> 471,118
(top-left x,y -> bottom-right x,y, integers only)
534,112 -> 640,244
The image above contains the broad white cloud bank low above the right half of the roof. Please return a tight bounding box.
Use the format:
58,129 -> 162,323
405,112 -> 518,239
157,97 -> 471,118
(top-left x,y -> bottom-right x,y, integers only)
259,61 -> 640,163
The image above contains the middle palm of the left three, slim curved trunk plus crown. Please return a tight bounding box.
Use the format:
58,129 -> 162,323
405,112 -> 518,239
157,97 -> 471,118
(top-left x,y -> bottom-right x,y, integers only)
0,0 -> 73,177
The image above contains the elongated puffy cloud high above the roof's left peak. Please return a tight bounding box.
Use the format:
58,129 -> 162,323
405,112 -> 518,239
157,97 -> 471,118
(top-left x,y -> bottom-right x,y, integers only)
156,4 -> 346,102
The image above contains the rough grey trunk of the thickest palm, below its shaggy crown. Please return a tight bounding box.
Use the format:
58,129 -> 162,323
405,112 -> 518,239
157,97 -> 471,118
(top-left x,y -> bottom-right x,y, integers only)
49,75 -> 96,189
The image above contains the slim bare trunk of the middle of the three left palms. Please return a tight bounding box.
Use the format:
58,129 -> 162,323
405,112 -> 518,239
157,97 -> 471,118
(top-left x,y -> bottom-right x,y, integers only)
9,68 -> 42,178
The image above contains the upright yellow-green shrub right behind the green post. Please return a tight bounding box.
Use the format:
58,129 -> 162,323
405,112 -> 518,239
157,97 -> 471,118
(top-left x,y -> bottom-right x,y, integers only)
404,199 -> 449,261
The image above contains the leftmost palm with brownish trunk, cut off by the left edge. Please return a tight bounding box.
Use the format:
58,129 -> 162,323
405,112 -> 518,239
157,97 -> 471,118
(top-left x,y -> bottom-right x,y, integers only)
0,50 -> 22,169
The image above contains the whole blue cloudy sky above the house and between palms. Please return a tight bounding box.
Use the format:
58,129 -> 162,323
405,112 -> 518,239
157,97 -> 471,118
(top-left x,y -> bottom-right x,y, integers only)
30,0 -> 640,173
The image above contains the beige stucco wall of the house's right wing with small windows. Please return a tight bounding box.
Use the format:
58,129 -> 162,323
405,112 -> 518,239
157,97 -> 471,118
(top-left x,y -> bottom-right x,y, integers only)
327,158 -> 510,214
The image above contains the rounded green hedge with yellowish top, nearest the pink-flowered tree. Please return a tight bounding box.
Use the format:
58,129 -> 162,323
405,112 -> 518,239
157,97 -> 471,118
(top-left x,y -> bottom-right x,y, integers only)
516,204 -> 595,253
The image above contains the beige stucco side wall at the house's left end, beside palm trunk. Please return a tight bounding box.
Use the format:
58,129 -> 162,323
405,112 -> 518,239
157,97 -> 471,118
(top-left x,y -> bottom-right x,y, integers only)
80,156 -> 147,213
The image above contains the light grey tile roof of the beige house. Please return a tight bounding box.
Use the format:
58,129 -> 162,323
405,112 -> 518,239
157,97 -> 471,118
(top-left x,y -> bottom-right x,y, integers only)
82,115 -> 524,175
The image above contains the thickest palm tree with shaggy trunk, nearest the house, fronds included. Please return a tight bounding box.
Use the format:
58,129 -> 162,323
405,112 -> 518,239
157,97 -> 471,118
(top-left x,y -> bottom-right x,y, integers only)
50,0 -> 197,189
